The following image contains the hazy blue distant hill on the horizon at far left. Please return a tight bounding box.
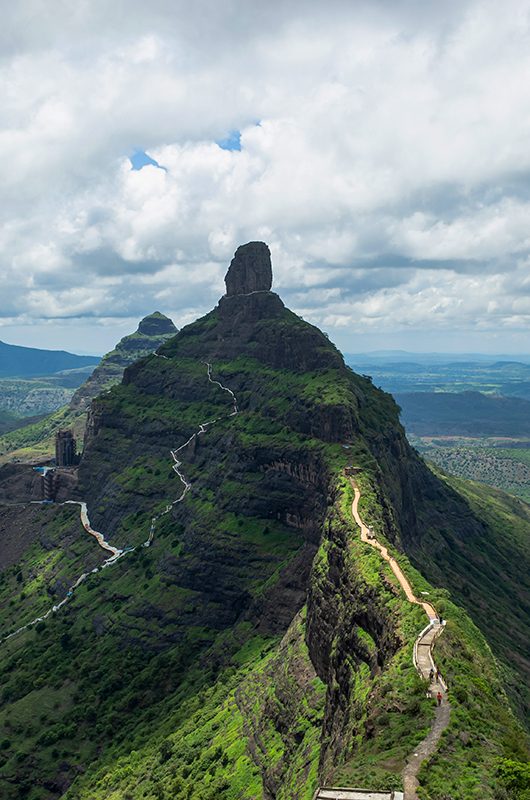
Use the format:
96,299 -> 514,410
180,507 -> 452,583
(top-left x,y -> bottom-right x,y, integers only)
0,341 -> 99,378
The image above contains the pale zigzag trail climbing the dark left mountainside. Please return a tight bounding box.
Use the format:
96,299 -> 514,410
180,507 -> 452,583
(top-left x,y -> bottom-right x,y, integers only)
0,362 -> 239,645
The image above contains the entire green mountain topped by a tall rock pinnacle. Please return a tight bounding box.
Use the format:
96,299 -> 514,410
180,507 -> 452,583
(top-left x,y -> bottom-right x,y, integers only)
0,242 -> 530,800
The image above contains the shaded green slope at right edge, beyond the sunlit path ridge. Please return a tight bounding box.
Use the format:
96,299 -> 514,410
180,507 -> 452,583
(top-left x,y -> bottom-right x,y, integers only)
407,466 -> 530,720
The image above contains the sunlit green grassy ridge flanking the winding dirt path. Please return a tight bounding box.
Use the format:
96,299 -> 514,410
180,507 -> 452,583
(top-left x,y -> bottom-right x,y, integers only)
324,474 -> 528,800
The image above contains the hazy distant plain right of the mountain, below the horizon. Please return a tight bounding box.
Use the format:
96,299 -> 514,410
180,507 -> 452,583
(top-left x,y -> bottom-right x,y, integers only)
346,351 -> 530,502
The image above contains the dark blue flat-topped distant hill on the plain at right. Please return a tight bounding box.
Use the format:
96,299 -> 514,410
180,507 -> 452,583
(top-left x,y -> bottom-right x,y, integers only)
395,392 -> 530,437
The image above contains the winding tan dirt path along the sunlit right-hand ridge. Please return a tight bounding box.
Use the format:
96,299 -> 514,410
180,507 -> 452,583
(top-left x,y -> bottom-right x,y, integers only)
351,480 -> 451,800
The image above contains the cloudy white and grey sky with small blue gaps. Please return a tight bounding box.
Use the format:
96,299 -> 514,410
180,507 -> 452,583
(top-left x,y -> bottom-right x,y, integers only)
0,0 -> 530,353
